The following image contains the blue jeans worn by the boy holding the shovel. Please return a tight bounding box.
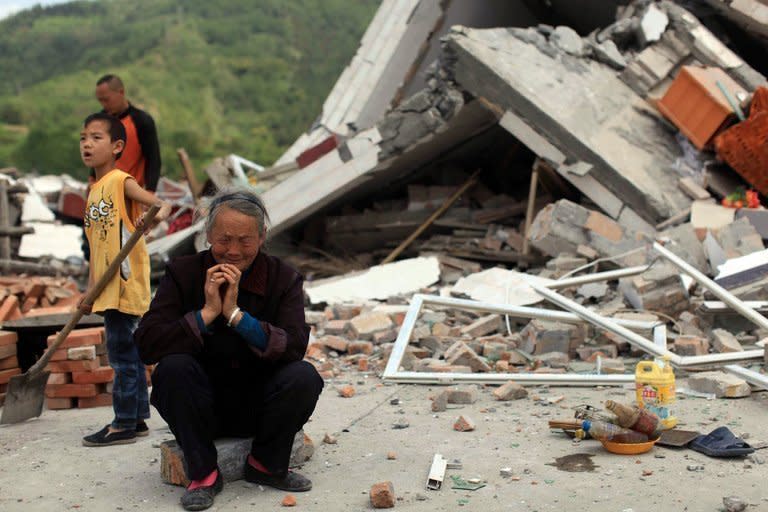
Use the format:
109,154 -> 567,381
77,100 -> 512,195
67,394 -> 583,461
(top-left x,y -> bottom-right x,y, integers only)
104,309 -> 149,430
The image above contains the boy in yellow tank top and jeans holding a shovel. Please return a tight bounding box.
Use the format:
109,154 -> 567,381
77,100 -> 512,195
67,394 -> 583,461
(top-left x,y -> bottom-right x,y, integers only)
80,112 -> 170,446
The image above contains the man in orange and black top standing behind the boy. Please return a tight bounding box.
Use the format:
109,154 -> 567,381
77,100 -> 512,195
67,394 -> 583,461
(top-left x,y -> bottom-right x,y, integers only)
96,75 -> 160,192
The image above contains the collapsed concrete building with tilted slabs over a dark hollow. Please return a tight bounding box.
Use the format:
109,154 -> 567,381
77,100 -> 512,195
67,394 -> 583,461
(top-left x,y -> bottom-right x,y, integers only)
244,1 -> 765,272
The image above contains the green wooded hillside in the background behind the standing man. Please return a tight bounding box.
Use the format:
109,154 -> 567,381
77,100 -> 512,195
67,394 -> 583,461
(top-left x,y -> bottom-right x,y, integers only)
0,0 -> 379,183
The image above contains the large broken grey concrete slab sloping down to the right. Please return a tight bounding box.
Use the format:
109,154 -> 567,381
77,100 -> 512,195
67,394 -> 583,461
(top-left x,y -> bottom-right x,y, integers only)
443,27 -> 690,224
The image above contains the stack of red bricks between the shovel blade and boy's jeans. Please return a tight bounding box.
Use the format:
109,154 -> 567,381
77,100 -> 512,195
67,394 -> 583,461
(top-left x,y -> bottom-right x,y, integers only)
45,327 -> 115,409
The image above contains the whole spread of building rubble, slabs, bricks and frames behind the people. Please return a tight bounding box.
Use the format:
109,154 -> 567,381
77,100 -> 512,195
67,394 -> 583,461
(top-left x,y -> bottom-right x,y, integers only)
0,0 -> 768,412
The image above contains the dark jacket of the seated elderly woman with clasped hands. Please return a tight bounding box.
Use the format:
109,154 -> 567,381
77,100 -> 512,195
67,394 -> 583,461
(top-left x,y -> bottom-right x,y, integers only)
134,251 -> 309,369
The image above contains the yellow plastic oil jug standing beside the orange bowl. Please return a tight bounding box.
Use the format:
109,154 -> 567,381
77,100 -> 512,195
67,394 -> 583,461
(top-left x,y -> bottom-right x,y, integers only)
635,360 -> 677,430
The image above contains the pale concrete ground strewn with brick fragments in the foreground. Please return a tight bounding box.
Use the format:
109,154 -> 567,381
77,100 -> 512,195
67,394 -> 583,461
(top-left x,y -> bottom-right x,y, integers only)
0,375 -> 768,512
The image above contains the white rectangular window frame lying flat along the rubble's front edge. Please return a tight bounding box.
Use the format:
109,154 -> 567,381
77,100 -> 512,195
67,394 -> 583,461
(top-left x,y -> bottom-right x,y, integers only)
382,294 -> 664,386
